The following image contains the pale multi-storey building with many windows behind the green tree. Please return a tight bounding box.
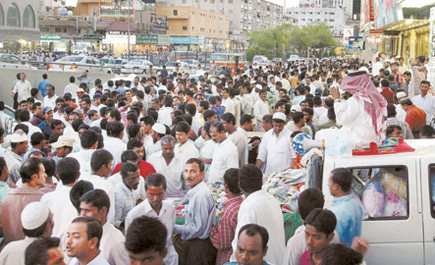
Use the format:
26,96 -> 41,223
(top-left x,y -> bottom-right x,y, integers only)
156,0 -> 291,43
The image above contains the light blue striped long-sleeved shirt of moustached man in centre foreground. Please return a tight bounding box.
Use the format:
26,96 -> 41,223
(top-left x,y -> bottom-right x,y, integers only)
174,181 -> 216,240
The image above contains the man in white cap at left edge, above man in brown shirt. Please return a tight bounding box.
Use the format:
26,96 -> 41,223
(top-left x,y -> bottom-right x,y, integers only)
4,129 -> 29,183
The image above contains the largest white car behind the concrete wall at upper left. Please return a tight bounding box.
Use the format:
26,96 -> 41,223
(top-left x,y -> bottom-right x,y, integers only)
48,55 -> 106,73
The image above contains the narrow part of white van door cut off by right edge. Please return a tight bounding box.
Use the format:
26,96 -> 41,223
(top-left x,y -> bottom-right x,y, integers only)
420,158 -> 435,264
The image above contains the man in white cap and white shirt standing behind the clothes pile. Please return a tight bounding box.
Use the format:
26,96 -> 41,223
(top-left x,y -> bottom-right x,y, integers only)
255,112 -> 296,174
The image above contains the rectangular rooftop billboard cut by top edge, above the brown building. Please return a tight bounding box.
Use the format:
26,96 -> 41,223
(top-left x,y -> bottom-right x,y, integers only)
98,0 -> 135,20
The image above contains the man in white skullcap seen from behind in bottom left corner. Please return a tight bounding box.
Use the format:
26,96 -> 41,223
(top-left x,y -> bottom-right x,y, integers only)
0,202 -> 53,265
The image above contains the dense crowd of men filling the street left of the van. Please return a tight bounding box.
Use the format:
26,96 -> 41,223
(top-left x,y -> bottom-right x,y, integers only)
0,50 -> 435,265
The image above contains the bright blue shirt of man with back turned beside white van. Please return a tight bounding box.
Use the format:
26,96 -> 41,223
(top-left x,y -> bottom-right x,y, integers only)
331,194 -> 363,247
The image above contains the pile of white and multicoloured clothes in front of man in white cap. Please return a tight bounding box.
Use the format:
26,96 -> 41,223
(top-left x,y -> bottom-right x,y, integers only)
263,169 -> 307,213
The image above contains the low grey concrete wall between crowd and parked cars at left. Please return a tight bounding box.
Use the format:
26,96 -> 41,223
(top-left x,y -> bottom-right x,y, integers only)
0,69 -> 115,107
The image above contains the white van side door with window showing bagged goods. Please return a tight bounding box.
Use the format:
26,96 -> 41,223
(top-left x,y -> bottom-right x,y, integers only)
332,158 -> 424,265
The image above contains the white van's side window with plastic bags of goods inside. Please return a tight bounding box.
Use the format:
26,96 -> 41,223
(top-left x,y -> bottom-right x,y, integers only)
350,166 -> 410,221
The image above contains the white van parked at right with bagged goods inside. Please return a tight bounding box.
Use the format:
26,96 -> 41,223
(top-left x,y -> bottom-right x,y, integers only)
307,139 -> 435,265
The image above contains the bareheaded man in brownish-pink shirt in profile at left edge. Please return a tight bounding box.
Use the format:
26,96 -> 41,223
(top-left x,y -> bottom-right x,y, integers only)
0,158 -> 47,244
